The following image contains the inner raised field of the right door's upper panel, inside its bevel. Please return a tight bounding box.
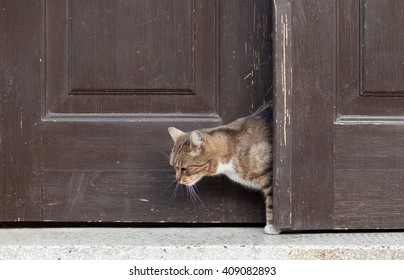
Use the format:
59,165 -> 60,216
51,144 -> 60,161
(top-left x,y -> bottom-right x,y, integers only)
359,0 -> 404,96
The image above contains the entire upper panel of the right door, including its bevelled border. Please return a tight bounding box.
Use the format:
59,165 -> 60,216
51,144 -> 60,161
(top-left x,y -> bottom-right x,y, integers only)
336,0 -> 404,118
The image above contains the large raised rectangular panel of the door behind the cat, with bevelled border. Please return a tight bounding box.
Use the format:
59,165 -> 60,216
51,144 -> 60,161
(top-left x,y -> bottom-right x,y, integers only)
45,0 -> 218,114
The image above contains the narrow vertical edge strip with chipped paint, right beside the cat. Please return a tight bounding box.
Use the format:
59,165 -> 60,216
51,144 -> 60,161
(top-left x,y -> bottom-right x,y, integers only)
273,0 -> 292,229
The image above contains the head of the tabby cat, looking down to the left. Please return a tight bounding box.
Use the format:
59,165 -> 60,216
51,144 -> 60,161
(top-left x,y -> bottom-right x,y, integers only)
168,127 -> 217,186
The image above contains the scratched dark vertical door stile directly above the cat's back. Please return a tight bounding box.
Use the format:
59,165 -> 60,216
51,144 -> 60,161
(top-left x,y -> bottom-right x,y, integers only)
218,0 -> 273,123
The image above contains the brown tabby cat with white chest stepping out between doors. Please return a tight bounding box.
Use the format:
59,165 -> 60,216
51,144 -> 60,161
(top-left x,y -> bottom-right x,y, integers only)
168,103 -> 279,234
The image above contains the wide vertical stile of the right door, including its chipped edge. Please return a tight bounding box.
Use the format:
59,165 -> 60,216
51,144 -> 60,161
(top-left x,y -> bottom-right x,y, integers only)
274,0 -> 336,231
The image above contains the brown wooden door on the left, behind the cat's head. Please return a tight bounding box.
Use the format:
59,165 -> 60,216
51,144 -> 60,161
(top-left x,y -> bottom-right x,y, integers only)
0,0 -> 272,223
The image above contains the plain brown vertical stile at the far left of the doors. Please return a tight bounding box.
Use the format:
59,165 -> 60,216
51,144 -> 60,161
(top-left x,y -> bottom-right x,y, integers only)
0,0 -> 43,221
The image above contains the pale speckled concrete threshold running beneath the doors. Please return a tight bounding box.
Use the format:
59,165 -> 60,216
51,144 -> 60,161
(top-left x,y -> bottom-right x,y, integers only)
0,227 -> 404,260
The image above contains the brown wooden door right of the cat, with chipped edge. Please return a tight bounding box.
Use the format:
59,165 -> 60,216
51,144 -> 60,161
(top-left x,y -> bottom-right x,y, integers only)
275,0 -> 404,230
